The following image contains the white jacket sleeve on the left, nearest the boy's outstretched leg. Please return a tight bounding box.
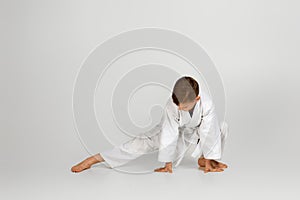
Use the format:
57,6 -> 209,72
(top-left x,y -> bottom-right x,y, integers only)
158,101 -> 179,162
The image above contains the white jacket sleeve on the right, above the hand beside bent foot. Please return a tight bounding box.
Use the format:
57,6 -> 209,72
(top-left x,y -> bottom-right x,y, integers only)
198,101 -> 222,159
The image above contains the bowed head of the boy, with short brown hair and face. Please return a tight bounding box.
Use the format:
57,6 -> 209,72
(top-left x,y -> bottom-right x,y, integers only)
172,76 -> 200,111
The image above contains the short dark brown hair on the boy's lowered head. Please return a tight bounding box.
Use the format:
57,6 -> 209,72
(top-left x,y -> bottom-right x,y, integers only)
172,76 -> 199,106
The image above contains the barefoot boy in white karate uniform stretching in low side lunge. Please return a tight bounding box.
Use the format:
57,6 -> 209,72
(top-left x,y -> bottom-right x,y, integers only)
71,76 -> 227,173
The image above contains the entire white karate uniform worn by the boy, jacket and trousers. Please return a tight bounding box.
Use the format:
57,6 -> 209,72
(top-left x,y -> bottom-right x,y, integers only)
100,93 -> 228,168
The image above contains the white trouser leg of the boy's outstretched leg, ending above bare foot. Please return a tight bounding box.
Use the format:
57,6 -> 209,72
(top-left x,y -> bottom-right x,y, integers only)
100,134 -> 159,168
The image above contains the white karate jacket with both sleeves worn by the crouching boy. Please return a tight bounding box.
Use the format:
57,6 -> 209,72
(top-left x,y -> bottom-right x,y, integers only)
158,93 -> 227,167
